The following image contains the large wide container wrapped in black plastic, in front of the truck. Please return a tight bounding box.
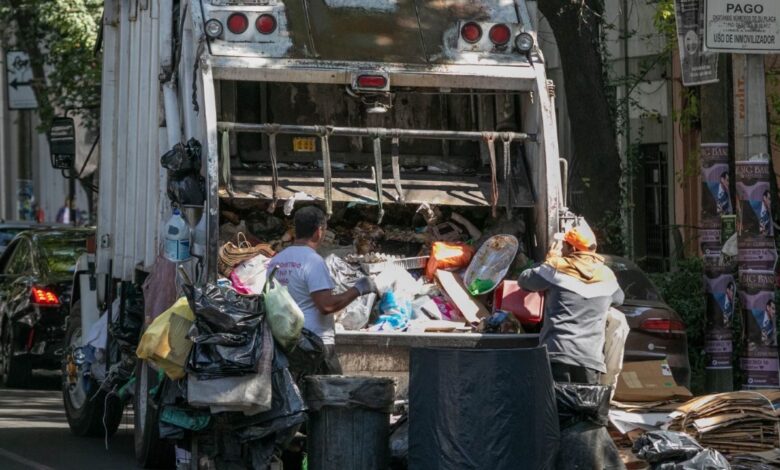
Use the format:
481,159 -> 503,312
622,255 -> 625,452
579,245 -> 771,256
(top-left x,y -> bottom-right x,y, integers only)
409,348 -> 560,470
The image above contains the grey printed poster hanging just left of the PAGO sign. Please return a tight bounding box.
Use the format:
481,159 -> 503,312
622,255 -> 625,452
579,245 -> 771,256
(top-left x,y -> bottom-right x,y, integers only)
674,0 -> 718,86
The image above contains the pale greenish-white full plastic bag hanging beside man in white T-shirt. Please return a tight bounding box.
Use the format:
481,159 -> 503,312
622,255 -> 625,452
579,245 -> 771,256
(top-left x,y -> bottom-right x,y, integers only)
263,268 -> 303,351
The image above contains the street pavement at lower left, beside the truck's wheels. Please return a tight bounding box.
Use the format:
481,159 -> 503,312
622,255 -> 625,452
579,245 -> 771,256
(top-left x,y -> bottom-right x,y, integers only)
0,371 -> 138,470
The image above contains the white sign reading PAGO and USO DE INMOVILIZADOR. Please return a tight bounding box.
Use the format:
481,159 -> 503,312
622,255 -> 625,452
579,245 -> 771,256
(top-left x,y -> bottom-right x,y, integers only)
704,0 -> 780,54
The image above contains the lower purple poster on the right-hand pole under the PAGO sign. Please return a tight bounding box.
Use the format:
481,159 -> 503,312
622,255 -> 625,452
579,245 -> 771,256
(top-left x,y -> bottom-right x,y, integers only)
739,270 -> 780,388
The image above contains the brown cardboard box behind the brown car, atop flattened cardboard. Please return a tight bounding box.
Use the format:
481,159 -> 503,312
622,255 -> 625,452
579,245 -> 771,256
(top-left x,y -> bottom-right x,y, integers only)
614,361 -> 692,402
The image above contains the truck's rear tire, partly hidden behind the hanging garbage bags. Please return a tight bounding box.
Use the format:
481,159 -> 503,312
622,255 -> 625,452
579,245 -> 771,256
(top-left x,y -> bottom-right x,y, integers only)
133,359 -> 175,468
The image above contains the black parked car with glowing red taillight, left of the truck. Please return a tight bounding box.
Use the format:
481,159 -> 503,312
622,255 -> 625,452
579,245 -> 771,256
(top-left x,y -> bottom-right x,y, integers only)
0,227 -> 95,386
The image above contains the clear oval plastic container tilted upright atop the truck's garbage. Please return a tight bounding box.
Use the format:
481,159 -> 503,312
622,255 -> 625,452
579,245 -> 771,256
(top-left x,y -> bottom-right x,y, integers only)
463,235 -> 520,296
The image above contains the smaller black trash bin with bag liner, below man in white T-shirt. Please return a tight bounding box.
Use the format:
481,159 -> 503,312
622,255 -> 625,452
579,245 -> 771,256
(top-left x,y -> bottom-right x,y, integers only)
305,375 -> 395,470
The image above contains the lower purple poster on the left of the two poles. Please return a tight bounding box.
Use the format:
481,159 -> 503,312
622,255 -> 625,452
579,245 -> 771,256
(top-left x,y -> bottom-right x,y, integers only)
704,267 -> 737,369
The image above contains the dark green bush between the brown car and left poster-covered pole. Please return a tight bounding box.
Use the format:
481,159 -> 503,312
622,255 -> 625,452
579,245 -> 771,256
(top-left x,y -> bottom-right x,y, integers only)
649,258 -> 707,395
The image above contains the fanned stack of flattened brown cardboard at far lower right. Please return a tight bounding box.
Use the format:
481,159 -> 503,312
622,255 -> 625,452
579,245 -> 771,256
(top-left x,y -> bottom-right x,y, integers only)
669,390 -> 780,454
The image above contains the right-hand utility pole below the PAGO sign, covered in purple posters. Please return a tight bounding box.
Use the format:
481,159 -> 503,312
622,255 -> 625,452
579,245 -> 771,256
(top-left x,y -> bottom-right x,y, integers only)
733,54 -> 780,389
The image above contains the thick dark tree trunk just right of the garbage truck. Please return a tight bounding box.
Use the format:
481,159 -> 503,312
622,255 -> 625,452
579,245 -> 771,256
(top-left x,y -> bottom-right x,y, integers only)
539,0 -> 622,252
